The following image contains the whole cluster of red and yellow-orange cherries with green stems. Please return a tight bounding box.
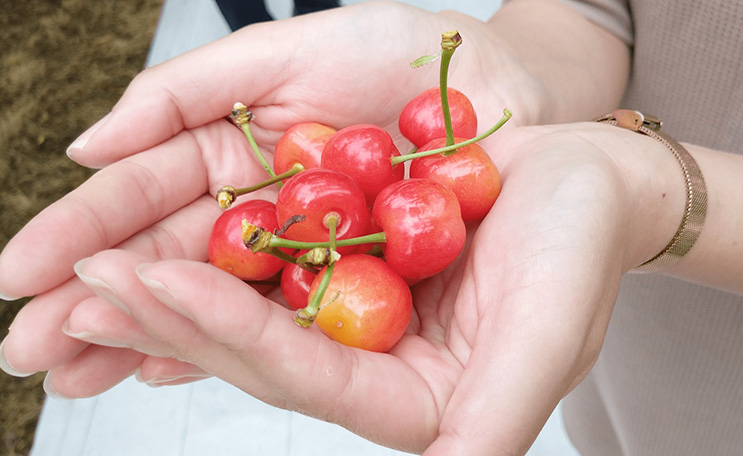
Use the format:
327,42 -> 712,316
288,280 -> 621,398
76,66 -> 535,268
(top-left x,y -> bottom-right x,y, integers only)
209,31 -> 511,351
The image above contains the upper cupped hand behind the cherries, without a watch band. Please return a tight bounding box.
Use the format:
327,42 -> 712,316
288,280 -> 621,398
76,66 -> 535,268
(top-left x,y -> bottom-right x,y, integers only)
0,2 -> 528,382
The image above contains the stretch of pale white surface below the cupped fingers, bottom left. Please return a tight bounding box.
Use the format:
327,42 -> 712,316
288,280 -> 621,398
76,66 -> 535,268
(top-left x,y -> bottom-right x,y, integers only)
31,379 -> 416,456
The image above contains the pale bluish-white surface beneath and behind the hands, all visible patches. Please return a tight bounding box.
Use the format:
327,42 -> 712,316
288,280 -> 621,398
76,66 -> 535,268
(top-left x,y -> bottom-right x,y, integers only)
31,0 -> 578,456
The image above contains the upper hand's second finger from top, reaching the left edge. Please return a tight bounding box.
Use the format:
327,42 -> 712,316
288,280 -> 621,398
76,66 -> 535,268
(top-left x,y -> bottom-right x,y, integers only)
0,134 -> 207,296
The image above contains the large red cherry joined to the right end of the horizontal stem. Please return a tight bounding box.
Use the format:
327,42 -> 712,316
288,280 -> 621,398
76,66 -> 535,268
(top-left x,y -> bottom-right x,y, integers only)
372,177 -> 466,283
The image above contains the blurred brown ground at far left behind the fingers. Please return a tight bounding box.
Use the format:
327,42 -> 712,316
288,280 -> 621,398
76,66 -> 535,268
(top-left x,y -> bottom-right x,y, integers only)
0,0 -> 163,456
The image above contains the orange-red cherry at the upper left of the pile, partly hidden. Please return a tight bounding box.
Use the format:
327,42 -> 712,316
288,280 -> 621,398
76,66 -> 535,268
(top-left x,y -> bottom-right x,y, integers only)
273,122 -> 336,174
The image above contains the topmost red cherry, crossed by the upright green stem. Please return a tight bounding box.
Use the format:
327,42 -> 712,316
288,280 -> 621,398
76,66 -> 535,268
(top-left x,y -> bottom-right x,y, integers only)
398,87 -> 477,148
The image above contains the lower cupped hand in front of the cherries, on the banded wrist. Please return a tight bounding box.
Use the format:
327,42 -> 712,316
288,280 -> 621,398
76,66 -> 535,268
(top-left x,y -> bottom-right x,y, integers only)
43,124 -> 657,455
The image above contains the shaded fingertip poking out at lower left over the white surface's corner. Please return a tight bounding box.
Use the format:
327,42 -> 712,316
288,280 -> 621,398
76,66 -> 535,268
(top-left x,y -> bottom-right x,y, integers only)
44,345 -> 146,398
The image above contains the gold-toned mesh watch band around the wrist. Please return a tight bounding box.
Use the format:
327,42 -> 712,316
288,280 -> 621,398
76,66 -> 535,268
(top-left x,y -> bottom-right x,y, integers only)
594,109 -> 707,272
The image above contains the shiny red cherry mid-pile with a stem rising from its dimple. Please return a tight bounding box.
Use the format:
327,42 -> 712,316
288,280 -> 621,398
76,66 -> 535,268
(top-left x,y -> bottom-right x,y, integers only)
276,168 -> 370,254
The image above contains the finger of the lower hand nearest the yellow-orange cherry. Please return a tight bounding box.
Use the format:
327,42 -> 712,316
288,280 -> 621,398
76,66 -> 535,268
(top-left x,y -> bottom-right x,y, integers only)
138,260 -> 438,450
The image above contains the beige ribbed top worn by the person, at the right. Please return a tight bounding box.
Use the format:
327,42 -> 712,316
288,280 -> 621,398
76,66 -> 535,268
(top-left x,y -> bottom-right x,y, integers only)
502,0 -> 743,456
